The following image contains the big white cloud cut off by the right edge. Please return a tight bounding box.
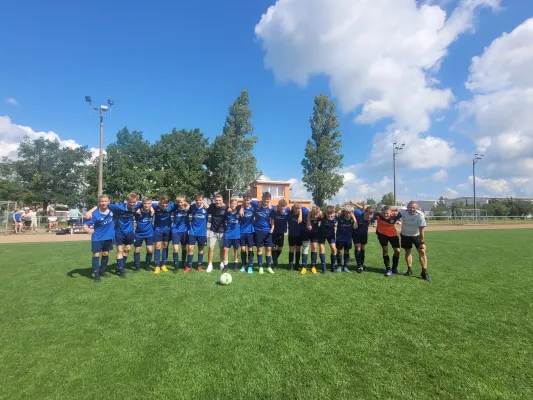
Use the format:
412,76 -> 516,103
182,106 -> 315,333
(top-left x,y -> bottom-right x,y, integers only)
460,18 -> 533,195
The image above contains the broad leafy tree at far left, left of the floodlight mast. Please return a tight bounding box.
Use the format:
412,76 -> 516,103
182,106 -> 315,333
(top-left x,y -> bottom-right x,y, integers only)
4,136 -> 91,210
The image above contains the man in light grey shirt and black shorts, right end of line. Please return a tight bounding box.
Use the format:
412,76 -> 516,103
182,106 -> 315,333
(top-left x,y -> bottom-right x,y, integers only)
398,201 -> 430,281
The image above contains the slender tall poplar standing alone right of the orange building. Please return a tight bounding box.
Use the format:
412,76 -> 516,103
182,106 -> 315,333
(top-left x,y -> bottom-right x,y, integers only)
302,94 -> 344,207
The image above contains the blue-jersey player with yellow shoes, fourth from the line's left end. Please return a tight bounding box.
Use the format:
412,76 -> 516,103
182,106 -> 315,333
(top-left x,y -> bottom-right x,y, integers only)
152,195 -> 176,275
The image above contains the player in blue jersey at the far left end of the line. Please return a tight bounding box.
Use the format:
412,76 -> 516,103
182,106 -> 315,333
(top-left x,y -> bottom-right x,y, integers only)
83,195 -> 115,283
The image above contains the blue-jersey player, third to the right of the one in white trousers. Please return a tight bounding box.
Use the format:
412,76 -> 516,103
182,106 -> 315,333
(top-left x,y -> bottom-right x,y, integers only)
251,192 -> 274,274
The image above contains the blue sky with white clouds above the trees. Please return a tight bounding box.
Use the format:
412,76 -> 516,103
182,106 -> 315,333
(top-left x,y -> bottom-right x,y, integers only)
0,0 -> 533,202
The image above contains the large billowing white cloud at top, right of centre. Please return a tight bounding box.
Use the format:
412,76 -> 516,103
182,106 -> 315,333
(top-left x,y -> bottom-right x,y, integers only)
255,0 -> 499,168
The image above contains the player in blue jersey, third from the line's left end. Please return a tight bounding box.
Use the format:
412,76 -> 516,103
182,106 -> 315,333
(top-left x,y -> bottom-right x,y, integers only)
133,197 -> 154,272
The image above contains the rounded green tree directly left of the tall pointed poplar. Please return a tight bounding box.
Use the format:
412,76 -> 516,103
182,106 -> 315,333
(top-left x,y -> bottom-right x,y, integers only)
149,128 -> 209,199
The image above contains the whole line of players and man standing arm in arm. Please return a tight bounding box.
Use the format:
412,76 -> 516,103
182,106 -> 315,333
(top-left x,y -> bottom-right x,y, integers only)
84,192 -> 429,283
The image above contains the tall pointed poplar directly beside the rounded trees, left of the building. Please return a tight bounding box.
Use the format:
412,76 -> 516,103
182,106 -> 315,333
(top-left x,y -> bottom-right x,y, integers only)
206,90 -> 261,201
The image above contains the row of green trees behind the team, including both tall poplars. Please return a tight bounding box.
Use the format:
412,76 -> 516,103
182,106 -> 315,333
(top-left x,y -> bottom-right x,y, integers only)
0,90 -> 343,210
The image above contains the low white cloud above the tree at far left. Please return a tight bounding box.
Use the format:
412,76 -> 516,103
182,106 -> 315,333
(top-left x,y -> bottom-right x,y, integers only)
0,115 -> 99,158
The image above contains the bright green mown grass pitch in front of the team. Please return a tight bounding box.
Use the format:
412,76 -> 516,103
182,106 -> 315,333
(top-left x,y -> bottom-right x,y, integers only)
0,230 -> 533,399
